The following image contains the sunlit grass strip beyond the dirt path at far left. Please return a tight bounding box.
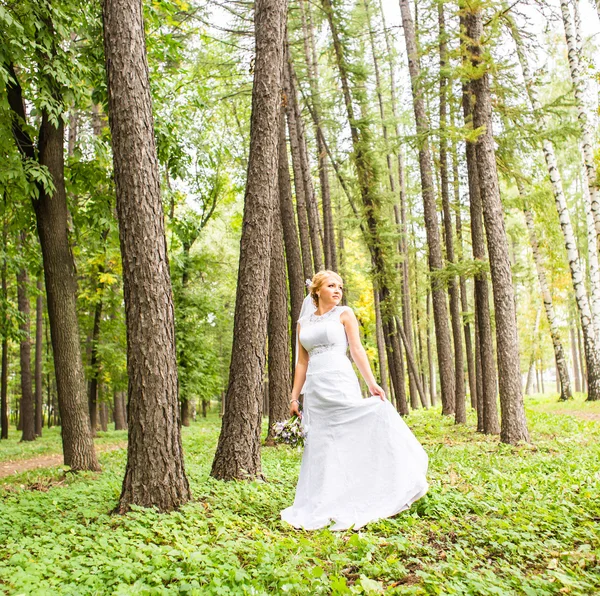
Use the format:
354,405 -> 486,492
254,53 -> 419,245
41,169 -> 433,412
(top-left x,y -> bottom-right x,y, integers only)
0,426 -> 127,463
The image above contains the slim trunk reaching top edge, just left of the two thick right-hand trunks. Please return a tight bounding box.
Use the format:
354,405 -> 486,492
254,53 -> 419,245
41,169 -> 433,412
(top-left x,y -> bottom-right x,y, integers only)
438,2 -> 467,424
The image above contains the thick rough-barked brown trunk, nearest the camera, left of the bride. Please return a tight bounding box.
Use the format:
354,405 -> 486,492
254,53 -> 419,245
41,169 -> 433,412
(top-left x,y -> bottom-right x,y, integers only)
103,0 -> 191,513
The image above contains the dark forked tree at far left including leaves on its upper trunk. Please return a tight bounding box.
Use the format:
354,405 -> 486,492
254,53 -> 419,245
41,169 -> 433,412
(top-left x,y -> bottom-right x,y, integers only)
5,15 -> 100,471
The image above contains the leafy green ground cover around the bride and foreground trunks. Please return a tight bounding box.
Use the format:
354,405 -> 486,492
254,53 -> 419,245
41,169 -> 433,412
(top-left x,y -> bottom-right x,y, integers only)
0,398 -> 600,596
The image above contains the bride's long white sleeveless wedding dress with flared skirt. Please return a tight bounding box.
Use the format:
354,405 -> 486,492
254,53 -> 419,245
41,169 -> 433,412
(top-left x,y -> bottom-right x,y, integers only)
281,306 -> 428,530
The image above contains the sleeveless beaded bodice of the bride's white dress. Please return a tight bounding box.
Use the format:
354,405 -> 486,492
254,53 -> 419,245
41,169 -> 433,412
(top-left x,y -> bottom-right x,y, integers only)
298,306 -> 349,358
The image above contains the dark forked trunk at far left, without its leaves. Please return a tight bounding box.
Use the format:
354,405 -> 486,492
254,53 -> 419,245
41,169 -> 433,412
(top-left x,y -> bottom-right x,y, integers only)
7,65 -> 100,471
